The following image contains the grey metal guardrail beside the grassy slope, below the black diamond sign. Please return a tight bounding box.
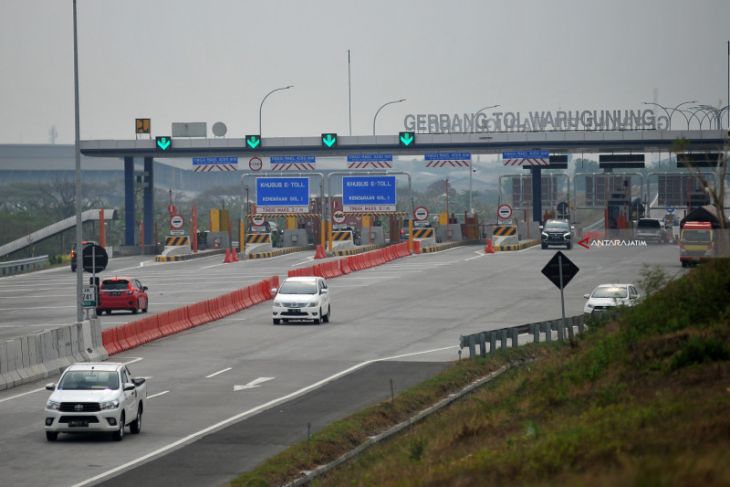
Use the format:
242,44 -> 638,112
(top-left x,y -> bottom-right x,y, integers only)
459,314 -> 586,358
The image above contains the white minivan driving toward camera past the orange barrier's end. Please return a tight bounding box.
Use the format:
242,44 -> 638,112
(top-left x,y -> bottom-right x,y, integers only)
273,276 -> 332,325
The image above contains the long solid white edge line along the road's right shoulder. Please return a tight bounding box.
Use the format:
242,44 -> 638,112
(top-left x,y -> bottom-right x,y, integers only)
72,345 -> 458,487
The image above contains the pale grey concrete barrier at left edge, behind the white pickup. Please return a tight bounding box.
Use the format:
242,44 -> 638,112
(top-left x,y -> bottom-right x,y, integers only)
0,319 -> 108,390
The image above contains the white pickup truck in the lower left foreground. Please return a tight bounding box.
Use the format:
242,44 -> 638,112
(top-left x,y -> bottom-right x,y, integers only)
44,362 -> 147,441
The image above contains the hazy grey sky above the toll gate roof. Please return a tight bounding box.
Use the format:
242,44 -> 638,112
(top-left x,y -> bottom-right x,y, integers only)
0,0 -> 730,143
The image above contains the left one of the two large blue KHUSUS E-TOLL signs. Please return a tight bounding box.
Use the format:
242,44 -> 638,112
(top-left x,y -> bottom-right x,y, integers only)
256,178 -> 309,213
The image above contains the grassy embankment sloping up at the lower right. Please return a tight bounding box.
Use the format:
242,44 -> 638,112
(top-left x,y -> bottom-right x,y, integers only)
233,260 -> 730,486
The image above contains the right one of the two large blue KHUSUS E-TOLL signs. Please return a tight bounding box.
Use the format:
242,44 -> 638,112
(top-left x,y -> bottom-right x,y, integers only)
342,176 -> 396,212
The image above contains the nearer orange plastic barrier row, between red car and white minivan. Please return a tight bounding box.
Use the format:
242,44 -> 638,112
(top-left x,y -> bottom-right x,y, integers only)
104,276 -> 279,356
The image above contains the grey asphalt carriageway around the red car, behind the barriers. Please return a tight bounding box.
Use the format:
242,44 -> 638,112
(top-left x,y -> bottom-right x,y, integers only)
0,252 -> 314,339
